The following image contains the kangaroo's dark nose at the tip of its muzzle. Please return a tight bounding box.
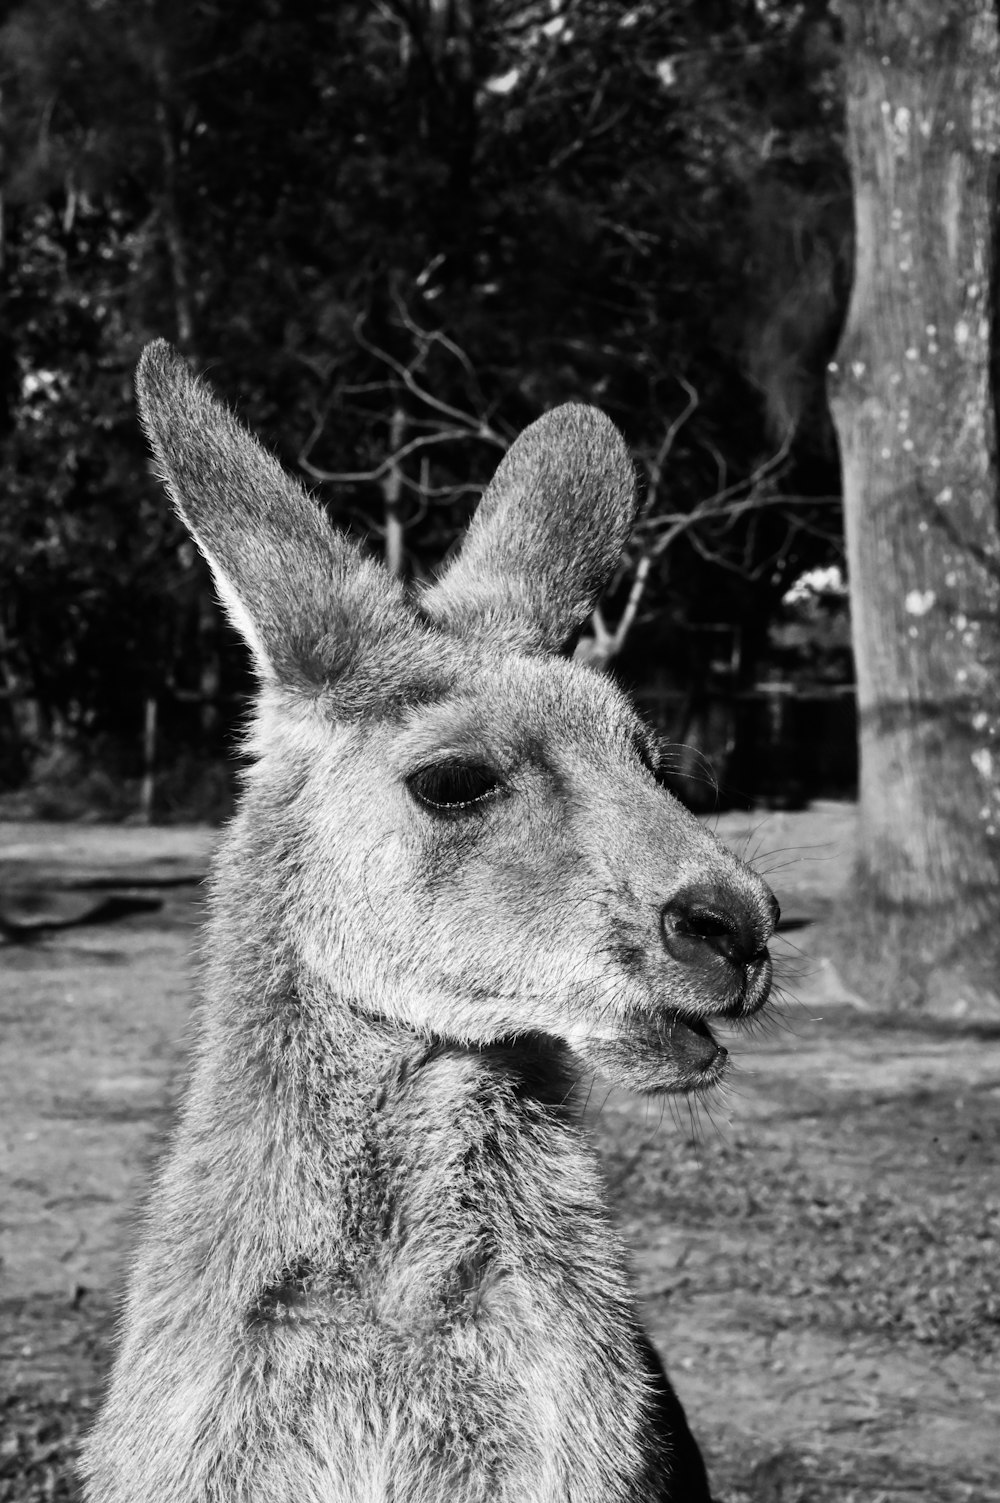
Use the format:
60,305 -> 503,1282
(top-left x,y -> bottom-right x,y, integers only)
660,882 -> 780,966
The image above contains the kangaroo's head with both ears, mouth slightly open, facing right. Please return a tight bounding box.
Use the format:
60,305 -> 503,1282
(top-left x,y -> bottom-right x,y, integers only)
137,341 -> 776,1091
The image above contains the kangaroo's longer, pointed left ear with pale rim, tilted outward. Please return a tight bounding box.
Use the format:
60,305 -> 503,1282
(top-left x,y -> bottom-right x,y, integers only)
135,340 -> 426,712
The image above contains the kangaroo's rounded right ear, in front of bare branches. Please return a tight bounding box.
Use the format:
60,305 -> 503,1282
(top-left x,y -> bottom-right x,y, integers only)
423,404 -> 636,652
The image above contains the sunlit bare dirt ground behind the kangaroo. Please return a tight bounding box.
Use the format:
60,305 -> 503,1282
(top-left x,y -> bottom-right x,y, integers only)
0,806 -> 1000,1503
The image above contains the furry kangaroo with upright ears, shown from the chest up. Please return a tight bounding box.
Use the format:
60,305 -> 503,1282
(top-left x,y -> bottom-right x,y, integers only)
84,341 -> 776,1503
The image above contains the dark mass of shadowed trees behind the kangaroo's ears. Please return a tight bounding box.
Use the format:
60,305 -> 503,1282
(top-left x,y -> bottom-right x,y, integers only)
0,0 -> 850,811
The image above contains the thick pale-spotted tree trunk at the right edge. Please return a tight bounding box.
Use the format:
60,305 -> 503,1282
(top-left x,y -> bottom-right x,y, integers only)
832,0 -> 1000,1015
